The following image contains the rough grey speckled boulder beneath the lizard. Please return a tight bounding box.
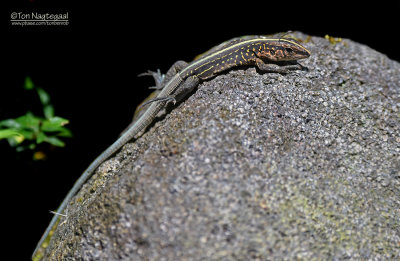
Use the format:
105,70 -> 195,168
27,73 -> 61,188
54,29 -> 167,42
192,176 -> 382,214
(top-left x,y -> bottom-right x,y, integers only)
45,34 -> 400,260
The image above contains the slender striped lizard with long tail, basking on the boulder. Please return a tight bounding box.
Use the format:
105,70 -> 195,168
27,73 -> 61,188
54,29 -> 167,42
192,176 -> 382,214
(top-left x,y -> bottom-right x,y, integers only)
32,36 -> 311,258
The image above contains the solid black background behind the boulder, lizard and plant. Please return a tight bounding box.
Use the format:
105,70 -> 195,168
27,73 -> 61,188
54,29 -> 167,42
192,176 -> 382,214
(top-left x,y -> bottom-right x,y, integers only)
0,0 -> 400,260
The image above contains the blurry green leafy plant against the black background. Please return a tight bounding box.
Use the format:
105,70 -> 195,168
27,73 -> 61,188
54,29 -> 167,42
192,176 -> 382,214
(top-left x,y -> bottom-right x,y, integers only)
0,77 -> 72,156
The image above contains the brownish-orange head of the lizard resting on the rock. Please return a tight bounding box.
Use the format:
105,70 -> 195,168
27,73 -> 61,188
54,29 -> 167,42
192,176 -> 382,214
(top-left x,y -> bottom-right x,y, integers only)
257,38 -> 311,62
